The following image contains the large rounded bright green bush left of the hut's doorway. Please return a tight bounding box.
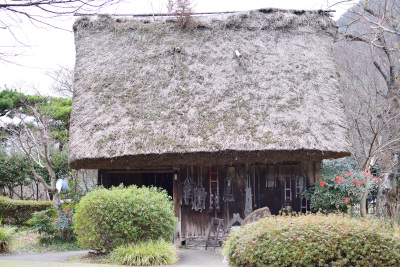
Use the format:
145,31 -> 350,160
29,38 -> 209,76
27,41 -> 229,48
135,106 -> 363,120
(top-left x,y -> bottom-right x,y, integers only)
74,185 -> 176,251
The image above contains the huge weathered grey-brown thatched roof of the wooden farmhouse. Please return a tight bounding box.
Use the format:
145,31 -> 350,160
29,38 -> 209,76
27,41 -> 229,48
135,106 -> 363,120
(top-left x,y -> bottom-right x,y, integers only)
69,10 -> 349,168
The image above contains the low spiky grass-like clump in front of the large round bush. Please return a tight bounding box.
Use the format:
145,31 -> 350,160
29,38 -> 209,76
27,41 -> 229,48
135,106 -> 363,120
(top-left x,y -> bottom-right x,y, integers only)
110,239 -> 179,266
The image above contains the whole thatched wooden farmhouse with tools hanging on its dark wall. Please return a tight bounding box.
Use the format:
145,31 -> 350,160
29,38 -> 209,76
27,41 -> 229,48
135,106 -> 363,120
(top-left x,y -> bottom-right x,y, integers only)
69,9 -> 350,245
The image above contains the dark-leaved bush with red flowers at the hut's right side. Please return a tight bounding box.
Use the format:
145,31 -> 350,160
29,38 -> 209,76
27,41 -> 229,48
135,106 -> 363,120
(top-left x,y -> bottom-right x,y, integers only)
304,171 -> 380,213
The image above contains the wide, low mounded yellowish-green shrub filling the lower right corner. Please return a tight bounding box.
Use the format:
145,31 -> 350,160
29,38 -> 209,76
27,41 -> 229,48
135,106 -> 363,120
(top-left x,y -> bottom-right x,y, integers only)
224,214 -> 400,266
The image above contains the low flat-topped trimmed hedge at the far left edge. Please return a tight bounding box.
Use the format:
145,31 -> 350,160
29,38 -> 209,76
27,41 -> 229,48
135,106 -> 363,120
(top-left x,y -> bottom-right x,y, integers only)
0,196 -> 53,225
